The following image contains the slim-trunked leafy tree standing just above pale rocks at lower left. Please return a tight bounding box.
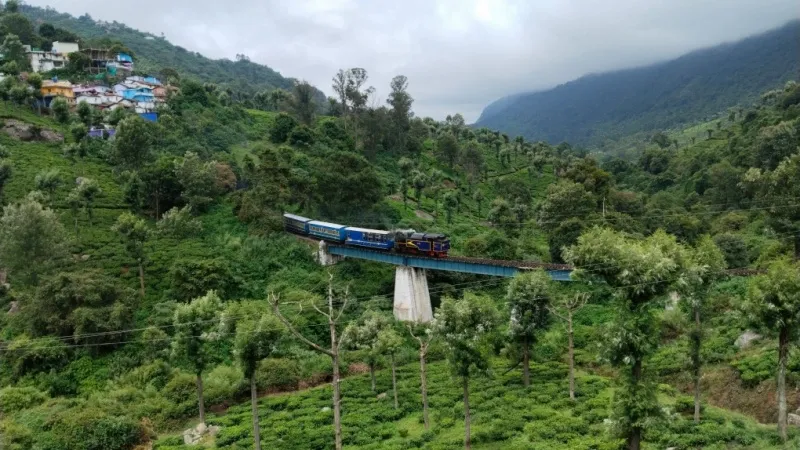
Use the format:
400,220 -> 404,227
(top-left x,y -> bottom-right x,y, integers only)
172,291 -> 222,423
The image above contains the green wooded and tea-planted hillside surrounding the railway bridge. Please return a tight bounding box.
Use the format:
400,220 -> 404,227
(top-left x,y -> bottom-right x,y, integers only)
0,2 -> 800,450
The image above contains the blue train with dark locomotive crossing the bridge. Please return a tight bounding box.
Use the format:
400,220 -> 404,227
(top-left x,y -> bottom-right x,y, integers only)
283,213 -> 450,258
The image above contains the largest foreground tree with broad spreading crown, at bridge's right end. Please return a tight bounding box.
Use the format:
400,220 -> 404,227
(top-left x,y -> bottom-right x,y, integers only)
565,227 -> 684,450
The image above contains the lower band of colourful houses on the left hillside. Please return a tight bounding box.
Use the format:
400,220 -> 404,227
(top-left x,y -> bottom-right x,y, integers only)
42,76 -> 171,121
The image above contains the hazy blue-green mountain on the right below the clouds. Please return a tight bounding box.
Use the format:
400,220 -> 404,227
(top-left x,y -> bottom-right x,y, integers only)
475,20 -> 800,146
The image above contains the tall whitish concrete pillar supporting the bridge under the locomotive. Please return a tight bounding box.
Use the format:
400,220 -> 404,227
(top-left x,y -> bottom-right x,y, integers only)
394,266 -> 433,323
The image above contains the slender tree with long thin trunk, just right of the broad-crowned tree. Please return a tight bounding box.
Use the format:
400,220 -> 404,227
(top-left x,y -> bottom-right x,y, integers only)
678,236 -> 726,423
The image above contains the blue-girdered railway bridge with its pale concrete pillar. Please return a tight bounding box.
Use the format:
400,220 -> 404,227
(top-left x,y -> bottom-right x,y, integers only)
317,241 -> 572,322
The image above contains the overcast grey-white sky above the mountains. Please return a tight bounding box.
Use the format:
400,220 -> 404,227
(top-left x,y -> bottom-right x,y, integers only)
27,0 -> 800,122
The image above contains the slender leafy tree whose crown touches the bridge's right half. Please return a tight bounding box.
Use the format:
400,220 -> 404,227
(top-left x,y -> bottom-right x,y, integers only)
506,270 -> 553,387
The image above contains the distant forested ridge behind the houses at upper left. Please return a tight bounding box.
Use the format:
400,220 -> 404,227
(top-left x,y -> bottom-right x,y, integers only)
20,5 -> 325,101
